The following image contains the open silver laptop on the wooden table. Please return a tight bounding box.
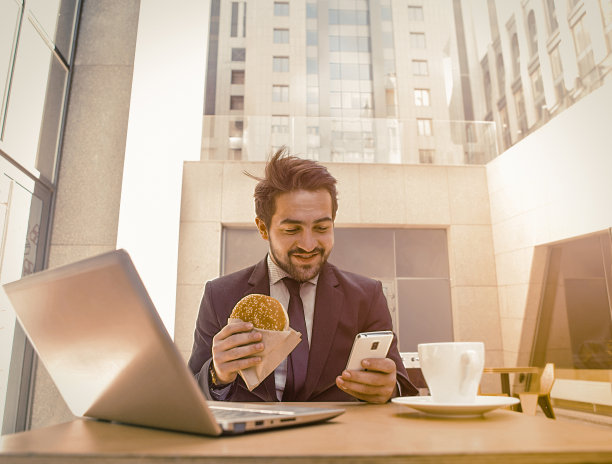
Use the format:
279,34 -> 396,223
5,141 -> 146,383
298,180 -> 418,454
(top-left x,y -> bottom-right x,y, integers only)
4,250 -> 344,436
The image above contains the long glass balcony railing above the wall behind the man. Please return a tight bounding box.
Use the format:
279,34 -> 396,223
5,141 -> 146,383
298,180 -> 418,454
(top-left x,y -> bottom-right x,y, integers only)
201,115 -> 499,165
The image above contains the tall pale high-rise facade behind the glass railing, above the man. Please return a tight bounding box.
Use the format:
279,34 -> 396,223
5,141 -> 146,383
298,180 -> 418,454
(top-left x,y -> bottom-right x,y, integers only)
202,0 -> 496,164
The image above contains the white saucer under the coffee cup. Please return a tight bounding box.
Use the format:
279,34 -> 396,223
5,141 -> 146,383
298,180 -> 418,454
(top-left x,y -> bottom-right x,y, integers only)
391,396 -> 520,416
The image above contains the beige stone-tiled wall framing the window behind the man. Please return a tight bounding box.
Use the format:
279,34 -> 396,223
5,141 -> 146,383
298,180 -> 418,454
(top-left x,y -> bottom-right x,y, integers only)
175,161 -> 503,392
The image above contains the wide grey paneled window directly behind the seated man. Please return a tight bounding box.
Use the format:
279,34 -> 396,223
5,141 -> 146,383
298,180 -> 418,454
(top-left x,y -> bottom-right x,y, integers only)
222,227 -> 453,351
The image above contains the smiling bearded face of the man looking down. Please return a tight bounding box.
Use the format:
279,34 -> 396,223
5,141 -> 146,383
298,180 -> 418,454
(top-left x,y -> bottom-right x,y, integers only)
255,189 -> 334,282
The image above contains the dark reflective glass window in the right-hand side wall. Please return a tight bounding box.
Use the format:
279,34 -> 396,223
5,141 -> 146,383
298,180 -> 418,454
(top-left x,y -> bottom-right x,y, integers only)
535,231 -> 612,369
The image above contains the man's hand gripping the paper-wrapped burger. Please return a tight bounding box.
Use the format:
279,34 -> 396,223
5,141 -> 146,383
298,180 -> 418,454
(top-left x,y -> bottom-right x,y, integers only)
212,322 -> 264,384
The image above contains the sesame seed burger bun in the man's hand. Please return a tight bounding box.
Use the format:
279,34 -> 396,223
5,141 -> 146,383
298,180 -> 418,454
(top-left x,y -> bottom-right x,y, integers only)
230,293 -> 289,330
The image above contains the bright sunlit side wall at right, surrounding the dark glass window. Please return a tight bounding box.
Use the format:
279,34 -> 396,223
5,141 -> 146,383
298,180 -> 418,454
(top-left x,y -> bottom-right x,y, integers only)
487,83 -> 612,366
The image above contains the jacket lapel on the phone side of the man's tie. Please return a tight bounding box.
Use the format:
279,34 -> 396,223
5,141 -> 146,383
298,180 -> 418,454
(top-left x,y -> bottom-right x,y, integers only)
299,264 -> 344,401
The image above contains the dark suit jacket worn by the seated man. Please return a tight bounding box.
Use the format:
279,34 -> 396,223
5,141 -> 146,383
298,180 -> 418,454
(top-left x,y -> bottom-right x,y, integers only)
189,259 -> 418,401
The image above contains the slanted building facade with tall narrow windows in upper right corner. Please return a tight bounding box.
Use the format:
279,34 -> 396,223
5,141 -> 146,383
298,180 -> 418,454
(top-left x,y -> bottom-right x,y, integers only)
466,0 -> 612,152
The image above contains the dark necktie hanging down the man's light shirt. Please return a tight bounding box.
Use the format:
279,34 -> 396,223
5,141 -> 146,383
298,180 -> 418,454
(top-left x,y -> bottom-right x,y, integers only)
283,277 -> 308,401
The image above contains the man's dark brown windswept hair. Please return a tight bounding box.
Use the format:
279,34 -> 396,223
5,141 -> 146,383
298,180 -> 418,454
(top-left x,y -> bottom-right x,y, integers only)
244,146 -> 338,227
